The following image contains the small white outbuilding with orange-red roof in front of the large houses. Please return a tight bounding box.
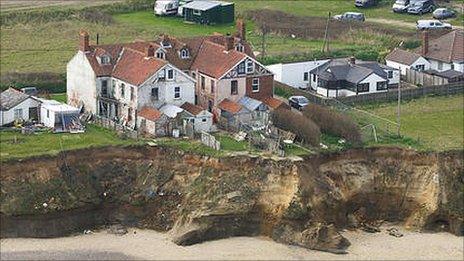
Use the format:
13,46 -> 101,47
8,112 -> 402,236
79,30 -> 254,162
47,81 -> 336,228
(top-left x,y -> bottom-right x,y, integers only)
181,102 -> 213,133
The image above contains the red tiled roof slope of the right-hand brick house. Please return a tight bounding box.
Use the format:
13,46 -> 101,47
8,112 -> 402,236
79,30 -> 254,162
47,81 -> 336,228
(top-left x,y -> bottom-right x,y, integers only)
191,41 -> 246,78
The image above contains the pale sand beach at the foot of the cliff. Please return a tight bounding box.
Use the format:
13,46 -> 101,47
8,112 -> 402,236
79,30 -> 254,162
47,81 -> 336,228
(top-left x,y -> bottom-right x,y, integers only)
0,225 -> 464,260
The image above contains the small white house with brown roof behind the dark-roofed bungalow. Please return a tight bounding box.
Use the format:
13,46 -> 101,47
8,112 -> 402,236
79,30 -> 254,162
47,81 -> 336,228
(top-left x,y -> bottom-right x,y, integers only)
385,48 -> 430,75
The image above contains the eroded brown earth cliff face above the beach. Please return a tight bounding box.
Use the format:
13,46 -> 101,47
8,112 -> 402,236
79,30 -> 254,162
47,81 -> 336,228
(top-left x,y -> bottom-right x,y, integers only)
0,147 -> 464,253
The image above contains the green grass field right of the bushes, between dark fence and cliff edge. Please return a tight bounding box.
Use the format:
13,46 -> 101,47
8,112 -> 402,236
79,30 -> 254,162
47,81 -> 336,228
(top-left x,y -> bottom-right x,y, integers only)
361,95 -> 464,151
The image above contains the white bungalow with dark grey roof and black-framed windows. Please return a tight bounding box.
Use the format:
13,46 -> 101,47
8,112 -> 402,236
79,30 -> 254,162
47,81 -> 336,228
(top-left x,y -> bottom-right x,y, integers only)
309,58 -> 399,97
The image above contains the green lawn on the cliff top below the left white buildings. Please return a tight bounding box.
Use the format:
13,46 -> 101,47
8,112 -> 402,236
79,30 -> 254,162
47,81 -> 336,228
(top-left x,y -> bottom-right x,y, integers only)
0,125 -> 135,161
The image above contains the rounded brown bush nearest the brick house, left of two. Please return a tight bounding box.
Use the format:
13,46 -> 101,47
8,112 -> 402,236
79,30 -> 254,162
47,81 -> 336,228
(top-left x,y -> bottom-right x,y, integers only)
271,106 -> 321,146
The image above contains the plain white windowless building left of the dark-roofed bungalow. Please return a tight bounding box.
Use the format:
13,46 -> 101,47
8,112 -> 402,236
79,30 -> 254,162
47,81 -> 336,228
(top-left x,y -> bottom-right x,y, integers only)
266,60 -> 329,89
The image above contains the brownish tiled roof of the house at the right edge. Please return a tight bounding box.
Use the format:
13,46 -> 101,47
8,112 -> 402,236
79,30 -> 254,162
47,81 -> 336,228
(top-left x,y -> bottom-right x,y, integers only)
416,30 -> 464,63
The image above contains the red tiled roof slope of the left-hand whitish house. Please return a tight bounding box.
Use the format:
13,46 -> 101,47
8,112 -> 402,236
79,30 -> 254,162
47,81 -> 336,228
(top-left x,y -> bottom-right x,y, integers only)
112,48 -> 167,85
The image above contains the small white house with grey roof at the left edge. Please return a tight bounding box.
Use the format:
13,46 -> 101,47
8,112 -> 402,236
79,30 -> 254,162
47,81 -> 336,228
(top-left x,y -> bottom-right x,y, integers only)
0,88 -> 40,126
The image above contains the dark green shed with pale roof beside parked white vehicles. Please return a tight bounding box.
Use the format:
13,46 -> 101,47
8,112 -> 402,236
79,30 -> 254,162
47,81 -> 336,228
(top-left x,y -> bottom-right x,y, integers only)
182,0 -> 235,24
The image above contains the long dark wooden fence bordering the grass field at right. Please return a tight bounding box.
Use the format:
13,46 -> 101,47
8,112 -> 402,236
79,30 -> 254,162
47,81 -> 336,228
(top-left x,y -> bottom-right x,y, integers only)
276,82 -> 464,106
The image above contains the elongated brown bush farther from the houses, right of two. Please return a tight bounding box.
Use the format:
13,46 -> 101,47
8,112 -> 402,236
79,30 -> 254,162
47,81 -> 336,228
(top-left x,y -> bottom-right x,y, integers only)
303,104 -> 361,145
